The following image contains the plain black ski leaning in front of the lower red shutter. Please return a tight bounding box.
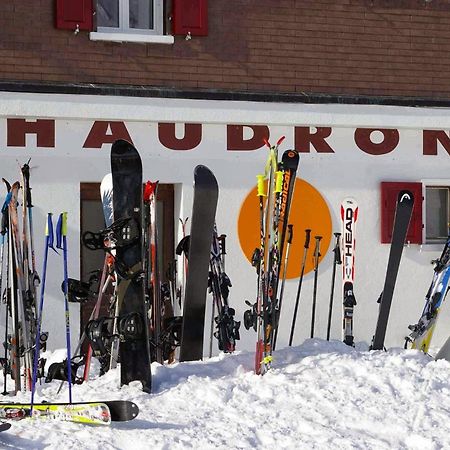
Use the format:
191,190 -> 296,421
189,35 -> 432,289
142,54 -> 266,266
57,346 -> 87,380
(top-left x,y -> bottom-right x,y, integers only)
371,190 -> 414,350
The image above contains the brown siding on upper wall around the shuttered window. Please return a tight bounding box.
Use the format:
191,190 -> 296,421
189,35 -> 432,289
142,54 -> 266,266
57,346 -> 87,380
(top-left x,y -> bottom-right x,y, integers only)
0,0 -> 450,98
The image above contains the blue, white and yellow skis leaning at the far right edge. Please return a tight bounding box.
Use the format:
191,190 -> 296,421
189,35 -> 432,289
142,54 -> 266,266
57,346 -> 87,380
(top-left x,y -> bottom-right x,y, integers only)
405,236 -> 450,359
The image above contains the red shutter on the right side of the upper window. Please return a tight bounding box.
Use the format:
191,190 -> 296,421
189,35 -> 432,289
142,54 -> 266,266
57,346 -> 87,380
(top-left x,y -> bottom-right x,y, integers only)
172,0 -> 208,36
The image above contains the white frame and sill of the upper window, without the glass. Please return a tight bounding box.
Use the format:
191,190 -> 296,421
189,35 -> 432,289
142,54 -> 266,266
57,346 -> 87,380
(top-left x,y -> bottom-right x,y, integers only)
89,0 -> 174,44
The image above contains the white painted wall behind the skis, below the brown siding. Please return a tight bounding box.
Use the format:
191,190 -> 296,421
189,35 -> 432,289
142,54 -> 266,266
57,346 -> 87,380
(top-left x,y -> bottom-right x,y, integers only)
0,93 -> 450,351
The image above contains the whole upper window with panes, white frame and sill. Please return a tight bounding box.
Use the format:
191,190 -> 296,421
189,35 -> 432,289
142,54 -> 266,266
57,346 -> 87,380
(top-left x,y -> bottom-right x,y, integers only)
90,0 -> 174,44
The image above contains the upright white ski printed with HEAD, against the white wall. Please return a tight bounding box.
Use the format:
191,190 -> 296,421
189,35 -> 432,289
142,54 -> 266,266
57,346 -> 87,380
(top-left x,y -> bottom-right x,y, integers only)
341,197 -> 358,346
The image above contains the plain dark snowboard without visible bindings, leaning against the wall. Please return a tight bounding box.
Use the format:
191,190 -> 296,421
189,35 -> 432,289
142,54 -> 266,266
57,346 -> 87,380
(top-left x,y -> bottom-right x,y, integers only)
180,166 -> 219,361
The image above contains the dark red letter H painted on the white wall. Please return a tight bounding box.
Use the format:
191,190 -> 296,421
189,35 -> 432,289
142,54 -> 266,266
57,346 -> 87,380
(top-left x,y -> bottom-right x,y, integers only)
6,119 -> 55,148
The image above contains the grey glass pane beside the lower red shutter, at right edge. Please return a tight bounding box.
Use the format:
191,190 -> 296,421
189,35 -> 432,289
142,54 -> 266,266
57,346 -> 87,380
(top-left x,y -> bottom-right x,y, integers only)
426,187 -> 449,239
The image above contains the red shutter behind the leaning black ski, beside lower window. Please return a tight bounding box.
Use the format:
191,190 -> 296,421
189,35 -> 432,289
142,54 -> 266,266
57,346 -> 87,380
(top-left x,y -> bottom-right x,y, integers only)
381,182 -> 423,244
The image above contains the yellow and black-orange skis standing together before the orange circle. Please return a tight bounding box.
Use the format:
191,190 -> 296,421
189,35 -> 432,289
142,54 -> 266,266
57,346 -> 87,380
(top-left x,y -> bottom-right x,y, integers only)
244,136 -> 299,375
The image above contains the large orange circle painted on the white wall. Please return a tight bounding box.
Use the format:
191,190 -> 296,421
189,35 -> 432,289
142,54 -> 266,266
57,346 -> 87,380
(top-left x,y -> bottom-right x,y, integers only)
238,178 -> 332,278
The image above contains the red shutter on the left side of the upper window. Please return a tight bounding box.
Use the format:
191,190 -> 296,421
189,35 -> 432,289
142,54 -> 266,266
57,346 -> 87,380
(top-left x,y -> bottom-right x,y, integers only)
56,0 -> 93,31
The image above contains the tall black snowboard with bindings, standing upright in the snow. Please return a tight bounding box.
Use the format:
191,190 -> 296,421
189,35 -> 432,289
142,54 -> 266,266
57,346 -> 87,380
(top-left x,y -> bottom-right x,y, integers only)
111,140 -> 151,392
